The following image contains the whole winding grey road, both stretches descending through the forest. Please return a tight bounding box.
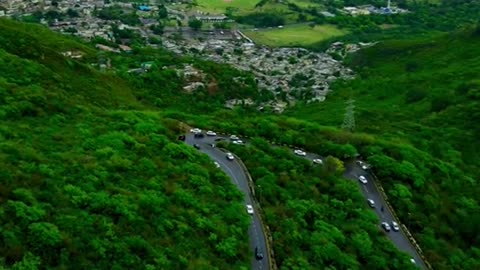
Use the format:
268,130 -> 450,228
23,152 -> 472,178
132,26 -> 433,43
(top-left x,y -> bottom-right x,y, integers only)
185,133 -> 427,270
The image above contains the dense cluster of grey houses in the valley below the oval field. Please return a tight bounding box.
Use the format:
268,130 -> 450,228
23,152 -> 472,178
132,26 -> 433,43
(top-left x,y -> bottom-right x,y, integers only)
164,35 -> 354,113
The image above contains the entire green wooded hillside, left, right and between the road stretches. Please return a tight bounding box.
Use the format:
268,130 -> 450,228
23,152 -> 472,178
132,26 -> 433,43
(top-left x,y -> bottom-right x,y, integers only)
0,14 -> 480,270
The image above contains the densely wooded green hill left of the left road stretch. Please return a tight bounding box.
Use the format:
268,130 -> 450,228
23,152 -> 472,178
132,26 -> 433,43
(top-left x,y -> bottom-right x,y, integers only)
0,20 -> 250,270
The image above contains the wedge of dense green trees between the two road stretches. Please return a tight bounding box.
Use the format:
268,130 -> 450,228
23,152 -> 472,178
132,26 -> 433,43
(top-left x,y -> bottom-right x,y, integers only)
223,138 -> 416,270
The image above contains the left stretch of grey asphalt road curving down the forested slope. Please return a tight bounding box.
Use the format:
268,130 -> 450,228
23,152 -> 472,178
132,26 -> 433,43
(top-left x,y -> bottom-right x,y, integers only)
185,134 -> 269,270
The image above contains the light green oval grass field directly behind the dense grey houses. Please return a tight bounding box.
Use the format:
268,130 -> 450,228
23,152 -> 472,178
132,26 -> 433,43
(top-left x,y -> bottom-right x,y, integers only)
245,24 -> 347,47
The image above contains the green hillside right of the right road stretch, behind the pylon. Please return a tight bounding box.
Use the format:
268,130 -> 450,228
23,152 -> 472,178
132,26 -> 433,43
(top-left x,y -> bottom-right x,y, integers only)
288,27 -> 480,269
